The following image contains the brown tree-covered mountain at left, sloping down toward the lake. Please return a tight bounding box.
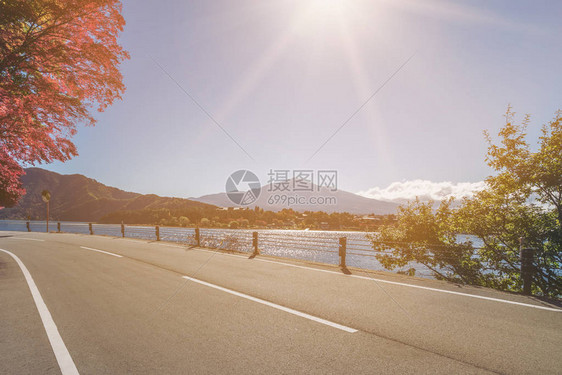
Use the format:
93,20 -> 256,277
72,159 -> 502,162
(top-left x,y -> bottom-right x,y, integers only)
0,168 -> 214,221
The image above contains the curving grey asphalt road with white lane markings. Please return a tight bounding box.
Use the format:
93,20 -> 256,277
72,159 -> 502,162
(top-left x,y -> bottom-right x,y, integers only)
0,232 -> 562,374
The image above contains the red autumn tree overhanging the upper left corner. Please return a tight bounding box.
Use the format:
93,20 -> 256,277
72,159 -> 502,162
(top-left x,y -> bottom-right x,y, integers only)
0,0 -> 129,207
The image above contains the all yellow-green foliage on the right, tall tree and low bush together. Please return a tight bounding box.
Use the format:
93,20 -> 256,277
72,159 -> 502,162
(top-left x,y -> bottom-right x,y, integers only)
371,109 -> 562,297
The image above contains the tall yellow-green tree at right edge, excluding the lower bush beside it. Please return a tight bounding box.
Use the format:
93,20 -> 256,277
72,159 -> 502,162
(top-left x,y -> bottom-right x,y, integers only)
458,109 -> 562,296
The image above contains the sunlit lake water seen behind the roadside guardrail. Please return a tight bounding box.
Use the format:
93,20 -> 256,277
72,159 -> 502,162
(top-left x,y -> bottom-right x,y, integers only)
0,220 -> 470,278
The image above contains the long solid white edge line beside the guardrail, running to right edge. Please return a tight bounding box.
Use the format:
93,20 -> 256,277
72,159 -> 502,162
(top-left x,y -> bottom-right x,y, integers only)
189,249 -> 562,312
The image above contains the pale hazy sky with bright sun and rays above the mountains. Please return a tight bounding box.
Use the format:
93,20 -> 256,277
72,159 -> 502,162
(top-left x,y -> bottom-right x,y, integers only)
41,0 -> 562,204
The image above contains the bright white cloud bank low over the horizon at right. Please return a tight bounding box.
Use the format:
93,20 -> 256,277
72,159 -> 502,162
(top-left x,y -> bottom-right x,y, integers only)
357,180 -> 486,203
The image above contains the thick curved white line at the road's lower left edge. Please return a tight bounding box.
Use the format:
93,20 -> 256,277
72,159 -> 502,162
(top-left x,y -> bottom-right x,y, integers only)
0,249 -> 78,375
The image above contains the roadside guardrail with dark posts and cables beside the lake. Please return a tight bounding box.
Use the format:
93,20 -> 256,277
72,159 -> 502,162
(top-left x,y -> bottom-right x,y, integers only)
2,221 -> 556,293
